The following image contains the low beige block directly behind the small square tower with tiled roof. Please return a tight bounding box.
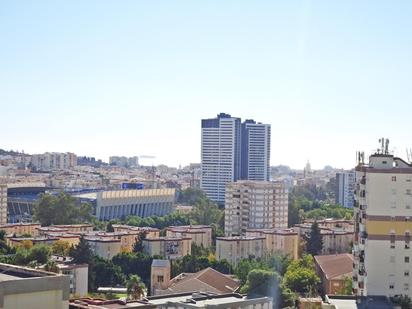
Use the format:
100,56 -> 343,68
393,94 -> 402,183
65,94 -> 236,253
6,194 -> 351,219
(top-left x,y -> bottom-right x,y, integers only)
143,237 -> 192,260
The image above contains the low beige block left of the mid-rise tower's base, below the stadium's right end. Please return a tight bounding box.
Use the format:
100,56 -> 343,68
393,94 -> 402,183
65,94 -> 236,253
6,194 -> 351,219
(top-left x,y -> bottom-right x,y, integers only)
166,225 -> 212,248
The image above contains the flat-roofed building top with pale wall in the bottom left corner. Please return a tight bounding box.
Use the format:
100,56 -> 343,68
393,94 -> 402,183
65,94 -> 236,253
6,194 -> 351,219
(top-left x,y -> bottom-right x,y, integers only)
0,264 -> 70,309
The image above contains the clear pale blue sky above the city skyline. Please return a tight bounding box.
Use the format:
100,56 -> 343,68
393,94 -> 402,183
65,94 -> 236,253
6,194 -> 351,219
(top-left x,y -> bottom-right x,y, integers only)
0,0 -> 412,168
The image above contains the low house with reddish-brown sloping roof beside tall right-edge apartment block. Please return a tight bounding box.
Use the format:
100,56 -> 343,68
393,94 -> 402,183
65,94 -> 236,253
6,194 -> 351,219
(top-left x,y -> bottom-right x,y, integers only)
315,253 -> 353,295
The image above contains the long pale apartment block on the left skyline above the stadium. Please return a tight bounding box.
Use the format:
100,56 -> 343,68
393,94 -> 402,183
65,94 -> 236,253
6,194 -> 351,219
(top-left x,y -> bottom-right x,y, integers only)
31,152 -> 77,171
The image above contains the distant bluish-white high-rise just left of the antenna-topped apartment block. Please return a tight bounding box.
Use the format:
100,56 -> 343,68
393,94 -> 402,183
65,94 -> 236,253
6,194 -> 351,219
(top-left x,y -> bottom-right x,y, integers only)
336,171 -> 356,208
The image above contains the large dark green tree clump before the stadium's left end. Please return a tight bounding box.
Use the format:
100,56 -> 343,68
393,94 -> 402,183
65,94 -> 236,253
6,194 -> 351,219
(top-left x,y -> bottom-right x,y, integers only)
33,192 -> 92,226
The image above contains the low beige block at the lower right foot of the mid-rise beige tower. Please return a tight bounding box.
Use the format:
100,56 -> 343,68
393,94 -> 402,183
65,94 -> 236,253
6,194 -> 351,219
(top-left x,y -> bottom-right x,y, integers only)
246,229 -> 300,260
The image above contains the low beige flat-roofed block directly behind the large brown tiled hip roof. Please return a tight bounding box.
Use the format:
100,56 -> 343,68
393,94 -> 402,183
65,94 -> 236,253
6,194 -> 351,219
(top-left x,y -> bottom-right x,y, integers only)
216,236 -> 265,265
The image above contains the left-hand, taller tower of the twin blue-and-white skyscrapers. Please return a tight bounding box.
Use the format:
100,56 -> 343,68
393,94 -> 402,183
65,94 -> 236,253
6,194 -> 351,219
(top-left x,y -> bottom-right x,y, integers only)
200,113 -> 241,205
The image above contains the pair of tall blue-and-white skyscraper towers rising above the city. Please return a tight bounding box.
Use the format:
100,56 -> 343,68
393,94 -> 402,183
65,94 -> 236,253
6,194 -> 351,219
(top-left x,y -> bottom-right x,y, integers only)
200,113 -> 271,205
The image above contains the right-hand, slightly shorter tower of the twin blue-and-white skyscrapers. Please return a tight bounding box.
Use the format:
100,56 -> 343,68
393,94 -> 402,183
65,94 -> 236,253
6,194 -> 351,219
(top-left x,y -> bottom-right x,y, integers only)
241,120 -> 270,181
